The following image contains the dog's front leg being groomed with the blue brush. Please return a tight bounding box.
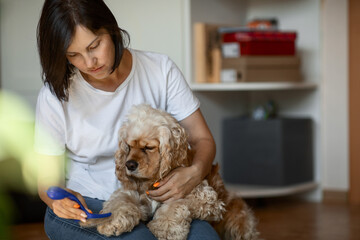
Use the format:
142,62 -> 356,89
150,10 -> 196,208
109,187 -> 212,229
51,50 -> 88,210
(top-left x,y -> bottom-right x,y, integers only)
93,190 -> 144,236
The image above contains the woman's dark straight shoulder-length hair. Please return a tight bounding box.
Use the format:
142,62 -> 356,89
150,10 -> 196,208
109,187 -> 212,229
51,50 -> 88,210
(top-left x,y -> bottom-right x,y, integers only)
37,0 -> 130,101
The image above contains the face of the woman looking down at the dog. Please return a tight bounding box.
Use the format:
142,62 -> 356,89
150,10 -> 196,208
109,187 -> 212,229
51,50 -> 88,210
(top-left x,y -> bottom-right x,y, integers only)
66,25 -> 115,80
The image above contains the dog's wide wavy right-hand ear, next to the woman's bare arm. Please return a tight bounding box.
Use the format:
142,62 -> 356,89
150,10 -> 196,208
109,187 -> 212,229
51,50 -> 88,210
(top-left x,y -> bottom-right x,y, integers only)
159,123 -> 189,179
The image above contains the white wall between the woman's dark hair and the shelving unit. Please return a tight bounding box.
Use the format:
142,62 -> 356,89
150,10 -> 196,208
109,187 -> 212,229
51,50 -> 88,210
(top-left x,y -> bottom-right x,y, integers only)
106,0 -> 185,77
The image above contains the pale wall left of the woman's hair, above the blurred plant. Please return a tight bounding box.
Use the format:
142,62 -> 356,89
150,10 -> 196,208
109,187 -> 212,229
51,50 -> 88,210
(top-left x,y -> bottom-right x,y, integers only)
0,0 -> 43,107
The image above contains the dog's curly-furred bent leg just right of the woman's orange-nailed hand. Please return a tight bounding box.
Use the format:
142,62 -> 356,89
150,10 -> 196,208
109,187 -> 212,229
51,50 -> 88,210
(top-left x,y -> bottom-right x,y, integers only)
186,180 -> 225,221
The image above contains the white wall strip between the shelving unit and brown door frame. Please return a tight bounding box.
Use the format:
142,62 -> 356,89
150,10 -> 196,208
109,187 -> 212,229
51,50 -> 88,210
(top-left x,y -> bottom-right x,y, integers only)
322,0 -> 349,190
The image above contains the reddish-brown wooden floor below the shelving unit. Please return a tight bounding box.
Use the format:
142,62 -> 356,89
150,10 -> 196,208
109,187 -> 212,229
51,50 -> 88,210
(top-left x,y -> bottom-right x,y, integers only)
7,200 -> 360,240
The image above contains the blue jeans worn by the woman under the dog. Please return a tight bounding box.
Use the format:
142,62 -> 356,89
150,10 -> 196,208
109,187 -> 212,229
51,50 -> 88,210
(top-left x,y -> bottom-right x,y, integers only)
45,197 -> 220,240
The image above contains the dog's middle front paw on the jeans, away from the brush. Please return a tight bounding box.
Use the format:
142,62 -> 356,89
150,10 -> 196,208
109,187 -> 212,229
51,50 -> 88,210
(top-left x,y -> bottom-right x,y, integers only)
147,199 -> 192,240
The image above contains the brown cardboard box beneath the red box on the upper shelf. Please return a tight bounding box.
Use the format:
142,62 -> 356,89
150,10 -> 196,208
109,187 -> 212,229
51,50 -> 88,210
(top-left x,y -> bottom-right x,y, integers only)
221,56 -> 301,82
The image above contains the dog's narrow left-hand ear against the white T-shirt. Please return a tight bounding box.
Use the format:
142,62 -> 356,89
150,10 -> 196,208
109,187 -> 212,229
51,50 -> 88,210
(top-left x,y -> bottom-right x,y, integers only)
115,125 -> 130,182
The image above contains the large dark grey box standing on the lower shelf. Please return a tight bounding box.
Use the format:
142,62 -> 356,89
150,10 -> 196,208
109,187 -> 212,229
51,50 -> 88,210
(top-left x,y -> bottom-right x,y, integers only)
222,118 -> 314,186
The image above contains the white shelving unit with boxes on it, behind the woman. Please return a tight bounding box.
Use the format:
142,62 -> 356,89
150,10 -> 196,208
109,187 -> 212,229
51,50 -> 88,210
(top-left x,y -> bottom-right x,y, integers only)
185,0 -> 321,200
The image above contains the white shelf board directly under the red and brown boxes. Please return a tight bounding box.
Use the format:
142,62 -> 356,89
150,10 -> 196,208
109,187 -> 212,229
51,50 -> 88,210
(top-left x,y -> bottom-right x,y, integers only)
190,82 -> 317,91
